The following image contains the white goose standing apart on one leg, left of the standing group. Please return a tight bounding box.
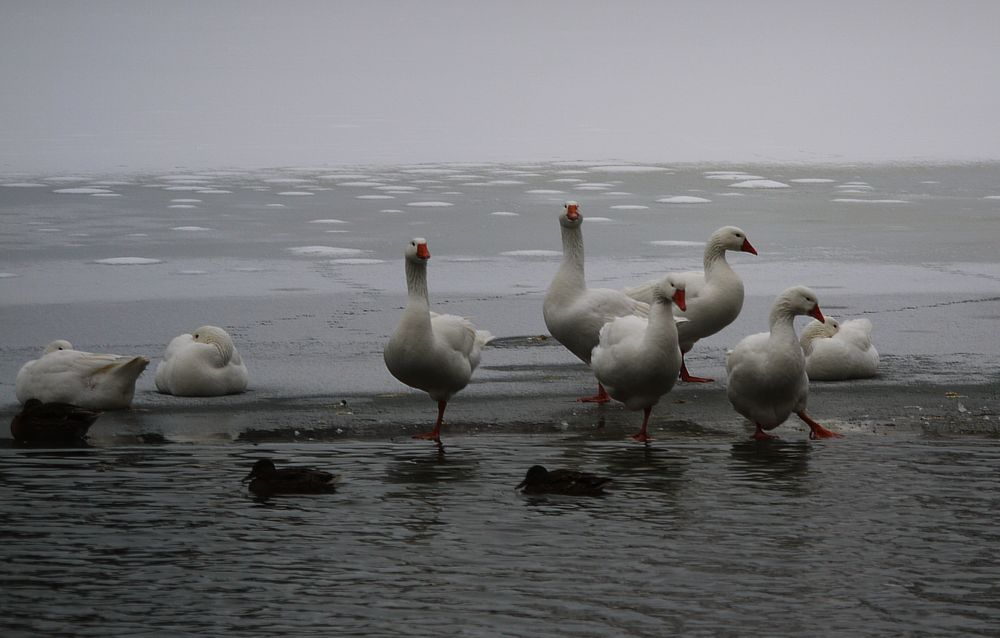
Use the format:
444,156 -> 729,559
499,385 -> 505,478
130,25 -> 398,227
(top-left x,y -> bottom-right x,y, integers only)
383,237 -> 493,444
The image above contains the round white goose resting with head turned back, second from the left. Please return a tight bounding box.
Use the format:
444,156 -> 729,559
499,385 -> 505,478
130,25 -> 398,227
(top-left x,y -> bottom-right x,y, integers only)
156,326 -> 249,397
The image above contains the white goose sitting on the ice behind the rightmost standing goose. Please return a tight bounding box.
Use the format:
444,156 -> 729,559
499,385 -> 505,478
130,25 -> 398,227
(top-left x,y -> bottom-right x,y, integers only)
799,317 -> 878,381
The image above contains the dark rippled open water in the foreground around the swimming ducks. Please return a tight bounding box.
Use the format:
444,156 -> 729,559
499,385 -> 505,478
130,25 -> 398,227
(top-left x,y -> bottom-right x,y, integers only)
0,434 -> 1000,636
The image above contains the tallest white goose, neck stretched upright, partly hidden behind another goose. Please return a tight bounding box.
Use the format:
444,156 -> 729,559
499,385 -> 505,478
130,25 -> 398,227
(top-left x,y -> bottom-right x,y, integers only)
542,202 -> 649,403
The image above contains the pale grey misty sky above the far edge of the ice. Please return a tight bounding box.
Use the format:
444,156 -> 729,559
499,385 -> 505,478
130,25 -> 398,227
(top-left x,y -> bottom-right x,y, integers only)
0,0 -> 1000,173
